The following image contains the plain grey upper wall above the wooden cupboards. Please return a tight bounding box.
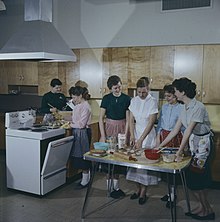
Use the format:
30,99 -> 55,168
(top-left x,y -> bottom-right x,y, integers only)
0,0 -> 220,48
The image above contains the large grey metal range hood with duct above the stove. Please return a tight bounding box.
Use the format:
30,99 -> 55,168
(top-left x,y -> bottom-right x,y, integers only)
0,0 -> 76,62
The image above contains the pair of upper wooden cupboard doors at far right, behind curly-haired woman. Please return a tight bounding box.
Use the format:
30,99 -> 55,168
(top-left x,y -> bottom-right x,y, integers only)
174,45 -> 220,104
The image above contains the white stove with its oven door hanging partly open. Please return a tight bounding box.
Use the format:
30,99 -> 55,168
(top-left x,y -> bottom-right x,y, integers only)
5,110 -> 73,195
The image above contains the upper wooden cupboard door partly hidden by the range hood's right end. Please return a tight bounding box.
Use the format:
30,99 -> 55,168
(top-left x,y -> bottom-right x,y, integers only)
65,49 -> 80,96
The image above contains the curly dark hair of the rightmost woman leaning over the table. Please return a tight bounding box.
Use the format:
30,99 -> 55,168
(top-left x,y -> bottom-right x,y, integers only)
172,77 -> 196,99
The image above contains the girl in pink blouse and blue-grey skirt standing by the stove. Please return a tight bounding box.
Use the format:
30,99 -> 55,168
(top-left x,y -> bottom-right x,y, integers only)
69,86 -> 91,189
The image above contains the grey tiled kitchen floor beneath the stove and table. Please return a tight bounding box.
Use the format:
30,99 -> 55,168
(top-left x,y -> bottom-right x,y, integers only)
0,155 -> 220,222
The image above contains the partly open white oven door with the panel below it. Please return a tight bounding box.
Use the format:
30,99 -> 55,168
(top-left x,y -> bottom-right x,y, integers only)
41,136 -> 73,195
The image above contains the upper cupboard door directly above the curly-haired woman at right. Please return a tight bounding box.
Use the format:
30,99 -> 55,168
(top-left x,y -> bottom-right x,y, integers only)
174,45 -> 203,100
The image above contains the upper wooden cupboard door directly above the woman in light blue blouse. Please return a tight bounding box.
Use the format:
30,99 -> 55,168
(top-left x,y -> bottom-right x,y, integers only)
150,46 -> 175,89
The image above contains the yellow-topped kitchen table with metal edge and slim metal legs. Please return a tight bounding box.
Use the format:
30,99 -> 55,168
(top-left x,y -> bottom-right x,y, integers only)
81,152 -> 191,222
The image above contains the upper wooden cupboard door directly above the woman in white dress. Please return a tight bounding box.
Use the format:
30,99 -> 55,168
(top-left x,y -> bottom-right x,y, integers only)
128,47 -> 150,88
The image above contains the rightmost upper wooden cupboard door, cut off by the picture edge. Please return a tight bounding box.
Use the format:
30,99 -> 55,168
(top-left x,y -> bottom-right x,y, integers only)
202,45 -> 220,104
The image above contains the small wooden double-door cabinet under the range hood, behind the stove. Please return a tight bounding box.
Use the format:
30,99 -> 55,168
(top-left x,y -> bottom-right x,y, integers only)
5,61 -> 38,86
